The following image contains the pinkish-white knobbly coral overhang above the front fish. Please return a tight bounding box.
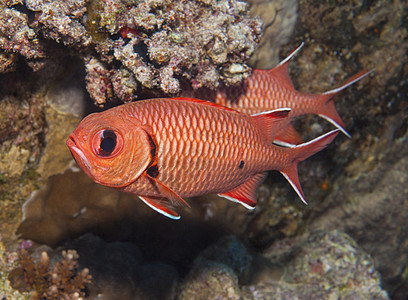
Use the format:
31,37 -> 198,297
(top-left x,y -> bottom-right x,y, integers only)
0,0 -> 262,106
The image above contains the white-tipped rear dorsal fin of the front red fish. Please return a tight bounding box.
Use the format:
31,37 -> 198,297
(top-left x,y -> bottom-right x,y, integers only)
251,108 -> 291,143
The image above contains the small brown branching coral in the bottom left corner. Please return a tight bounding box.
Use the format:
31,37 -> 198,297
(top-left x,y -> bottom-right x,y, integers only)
8,250 -> 91,299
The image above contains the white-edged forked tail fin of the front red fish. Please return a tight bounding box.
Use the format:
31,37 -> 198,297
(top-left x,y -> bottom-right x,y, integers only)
279,129 -> 339,204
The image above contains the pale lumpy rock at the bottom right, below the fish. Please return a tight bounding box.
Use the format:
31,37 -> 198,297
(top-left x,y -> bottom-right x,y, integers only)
244,230 -> 389,300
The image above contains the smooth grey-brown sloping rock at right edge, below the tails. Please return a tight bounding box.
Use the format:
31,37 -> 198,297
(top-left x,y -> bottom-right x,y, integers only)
310,114 -> 408,297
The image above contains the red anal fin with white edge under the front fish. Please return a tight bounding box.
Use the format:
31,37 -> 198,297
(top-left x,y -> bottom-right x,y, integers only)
218,172 -> 267,209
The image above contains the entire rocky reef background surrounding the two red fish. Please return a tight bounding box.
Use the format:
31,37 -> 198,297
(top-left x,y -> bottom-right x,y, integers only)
0,0 -> 408,299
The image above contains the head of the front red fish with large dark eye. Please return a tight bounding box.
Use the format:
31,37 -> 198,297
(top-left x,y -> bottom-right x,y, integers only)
66,110 -> 153,188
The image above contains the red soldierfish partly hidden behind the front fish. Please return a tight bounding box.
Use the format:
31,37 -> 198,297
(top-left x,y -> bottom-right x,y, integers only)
183,43 -> 372,144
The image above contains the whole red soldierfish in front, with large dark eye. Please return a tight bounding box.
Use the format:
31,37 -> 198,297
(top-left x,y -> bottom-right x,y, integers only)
67,98 -> 338,219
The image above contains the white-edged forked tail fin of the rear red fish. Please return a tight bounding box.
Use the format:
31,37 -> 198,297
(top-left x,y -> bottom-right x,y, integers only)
316,69 -> 374,138
